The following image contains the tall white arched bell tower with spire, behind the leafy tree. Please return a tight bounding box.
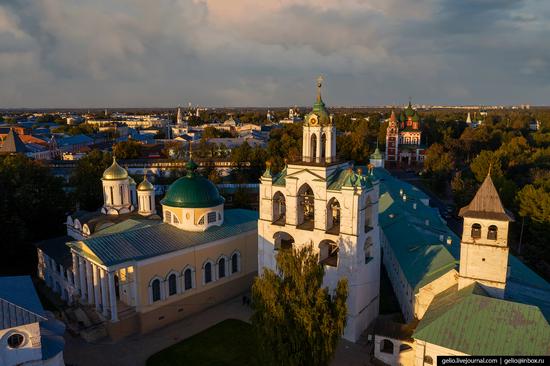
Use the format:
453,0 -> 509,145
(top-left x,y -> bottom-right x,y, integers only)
258,79 -> 380,341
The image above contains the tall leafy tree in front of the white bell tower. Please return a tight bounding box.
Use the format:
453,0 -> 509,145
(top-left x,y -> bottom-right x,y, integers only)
252,244 -> 348,366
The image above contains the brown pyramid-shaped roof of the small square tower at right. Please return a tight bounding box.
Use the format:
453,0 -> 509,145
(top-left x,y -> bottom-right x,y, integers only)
460,174 -> 514,221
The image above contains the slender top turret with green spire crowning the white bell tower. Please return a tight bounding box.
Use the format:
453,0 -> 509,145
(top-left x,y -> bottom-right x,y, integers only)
302,76 -> 336,164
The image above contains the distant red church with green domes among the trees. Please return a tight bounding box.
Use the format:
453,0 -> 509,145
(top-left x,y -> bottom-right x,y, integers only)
385,102 -> 425,166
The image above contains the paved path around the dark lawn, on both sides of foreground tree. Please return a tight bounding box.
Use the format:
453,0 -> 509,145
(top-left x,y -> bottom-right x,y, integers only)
65,297 -> 376,366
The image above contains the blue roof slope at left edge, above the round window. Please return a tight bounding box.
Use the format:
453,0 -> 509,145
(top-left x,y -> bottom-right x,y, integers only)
0,276 -> 46,329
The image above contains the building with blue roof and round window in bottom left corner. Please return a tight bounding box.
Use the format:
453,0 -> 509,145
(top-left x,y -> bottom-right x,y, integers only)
0,276 -> 65,366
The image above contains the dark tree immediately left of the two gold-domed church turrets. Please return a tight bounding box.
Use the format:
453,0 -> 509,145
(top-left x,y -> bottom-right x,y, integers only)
70,150 -> 112,211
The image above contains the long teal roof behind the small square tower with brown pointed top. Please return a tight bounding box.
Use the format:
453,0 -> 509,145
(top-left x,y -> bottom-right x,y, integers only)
374,168 -> 550,319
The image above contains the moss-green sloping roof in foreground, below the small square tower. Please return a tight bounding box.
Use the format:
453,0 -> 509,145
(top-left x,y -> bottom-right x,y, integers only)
413,284 -> 550,356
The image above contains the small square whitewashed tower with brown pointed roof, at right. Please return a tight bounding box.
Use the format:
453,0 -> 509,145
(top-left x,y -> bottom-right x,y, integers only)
458,173 -> 514,298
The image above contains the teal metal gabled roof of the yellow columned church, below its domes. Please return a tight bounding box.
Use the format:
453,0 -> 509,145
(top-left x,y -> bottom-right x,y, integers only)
67,209 -> 258,266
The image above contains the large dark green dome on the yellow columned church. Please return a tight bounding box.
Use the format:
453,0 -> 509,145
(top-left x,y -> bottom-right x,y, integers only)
160,173 -> 225,208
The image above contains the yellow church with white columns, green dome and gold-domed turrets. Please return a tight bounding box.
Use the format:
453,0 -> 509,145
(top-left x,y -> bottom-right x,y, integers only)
38,161 -> 258,339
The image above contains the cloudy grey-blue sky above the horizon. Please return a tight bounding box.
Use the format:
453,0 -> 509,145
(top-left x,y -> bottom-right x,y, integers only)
0,0 -> 550,108
